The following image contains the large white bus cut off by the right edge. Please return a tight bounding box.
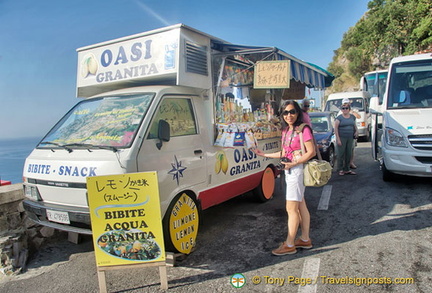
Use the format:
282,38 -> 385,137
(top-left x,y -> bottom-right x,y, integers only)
372,53 -> 432,181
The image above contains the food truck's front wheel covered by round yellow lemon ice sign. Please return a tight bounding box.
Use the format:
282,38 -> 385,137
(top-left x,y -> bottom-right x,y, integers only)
163,192 -> 200,254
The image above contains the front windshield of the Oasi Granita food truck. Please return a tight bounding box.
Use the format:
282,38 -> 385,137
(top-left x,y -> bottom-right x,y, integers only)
38,93 -> 155,151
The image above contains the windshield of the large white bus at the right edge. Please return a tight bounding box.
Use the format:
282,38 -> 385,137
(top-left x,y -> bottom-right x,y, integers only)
387,60 -> 432,109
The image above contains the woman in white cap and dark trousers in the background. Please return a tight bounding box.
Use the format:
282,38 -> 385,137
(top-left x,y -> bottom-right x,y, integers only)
335,99 -> 357,175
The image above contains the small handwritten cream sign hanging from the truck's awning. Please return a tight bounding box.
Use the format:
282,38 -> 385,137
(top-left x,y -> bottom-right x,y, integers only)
254,60 -> 291,89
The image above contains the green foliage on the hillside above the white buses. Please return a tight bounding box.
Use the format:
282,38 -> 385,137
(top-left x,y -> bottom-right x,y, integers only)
328,0 -> 432,90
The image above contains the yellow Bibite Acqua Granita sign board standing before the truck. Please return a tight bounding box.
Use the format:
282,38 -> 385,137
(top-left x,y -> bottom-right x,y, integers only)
87,172 -> 165,266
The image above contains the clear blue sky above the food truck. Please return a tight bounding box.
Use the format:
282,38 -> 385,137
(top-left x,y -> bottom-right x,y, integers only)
0,0 -> 369,139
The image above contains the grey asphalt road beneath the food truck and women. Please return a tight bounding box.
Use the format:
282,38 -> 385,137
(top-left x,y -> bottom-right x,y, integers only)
0,143 -> 432,293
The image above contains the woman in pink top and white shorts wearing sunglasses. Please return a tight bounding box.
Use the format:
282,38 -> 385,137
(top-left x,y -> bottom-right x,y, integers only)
254,100 -> 315,255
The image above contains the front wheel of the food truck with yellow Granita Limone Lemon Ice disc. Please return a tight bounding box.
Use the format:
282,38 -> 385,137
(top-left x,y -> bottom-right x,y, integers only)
162,192 -> 201,254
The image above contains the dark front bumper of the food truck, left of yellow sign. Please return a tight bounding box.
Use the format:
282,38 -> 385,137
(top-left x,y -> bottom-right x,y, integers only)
23,199 -> 92,235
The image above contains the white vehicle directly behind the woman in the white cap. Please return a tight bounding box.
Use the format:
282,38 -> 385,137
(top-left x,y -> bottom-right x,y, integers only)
324,91 -> 371,141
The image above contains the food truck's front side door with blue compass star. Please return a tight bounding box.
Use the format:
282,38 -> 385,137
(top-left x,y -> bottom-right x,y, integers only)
137,96 -> 207,201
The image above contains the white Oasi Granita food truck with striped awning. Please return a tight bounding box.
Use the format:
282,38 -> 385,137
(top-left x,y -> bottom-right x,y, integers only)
23,24 -> 329,254
